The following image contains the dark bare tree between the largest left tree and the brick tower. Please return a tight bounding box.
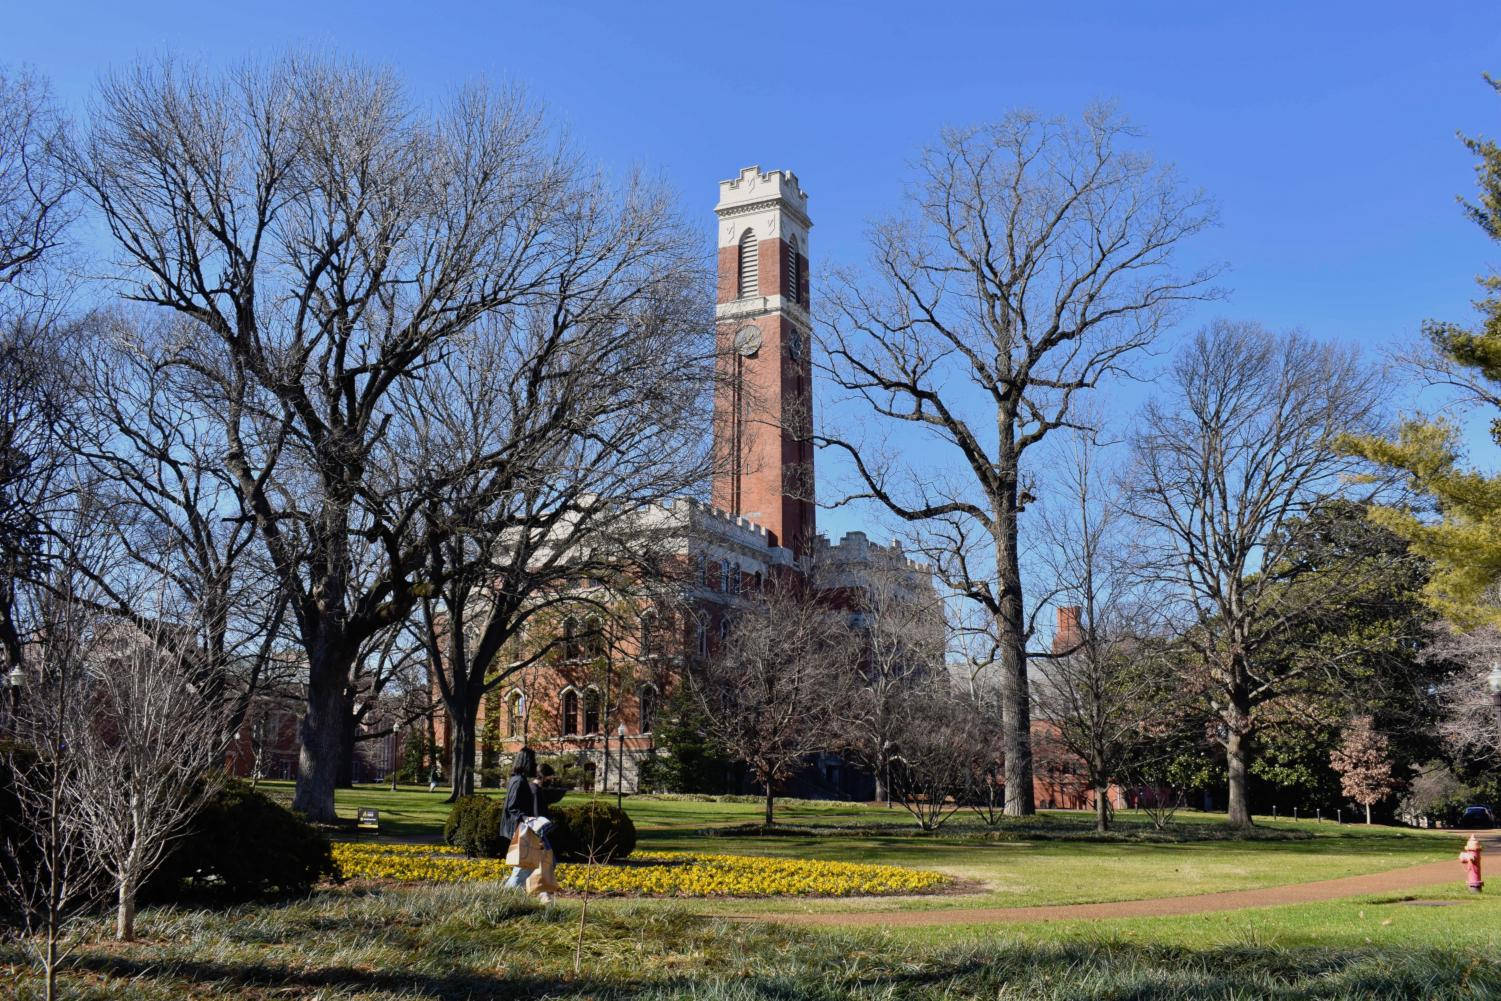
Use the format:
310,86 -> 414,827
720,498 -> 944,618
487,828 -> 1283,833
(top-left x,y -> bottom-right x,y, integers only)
404,193 -> 714,797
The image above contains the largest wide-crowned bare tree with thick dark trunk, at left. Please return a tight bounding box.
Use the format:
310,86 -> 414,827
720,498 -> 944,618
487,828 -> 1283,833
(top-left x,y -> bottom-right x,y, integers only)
74,59 -> 669,821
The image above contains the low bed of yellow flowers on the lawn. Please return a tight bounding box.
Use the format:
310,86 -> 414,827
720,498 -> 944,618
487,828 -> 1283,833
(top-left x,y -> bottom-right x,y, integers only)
333,842 -> 949,897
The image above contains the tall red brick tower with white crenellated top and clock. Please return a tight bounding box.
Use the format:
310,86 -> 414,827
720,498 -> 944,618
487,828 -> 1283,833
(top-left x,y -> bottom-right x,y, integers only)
713,167 -> 815,557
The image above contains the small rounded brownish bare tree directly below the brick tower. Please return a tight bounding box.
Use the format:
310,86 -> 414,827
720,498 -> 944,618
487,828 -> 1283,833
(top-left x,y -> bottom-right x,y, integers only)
686,576 -> 857,827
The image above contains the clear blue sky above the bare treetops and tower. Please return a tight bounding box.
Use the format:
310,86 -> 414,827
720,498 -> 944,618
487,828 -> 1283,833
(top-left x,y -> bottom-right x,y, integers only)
0,0 -> 1501,549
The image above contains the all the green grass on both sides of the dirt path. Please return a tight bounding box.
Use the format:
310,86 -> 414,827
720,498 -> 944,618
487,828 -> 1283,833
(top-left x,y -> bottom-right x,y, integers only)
0,785 -> 1501,1001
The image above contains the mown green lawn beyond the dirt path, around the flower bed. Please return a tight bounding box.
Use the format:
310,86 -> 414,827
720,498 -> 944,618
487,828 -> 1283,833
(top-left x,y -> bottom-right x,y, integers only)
258,785 -> 1459,914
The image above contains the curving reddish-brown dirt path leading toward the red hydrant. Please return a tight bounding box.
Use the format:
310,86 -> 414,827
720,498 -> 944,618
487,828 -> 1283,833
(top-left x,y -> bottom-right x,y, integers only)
741,831 -> 1482,927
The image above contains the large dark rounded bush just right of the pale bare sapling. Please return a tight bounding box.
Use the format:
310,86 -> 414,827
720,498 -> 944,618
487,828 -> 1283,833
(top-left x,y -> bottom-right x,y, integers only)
147,780 -> 338,902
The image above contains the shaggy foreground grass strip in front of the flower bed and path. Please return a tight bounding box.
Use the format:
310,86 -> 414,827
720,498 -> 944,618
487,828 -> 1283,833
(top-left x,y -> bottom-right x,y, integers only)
0,884 -> 1501,1001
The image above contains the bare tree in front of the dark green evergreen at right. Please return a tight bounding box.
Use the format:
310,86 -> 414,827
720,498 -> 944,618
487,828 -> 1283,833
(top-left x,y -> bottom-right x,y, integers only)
1130,321 -> 1381,825
